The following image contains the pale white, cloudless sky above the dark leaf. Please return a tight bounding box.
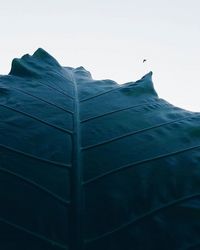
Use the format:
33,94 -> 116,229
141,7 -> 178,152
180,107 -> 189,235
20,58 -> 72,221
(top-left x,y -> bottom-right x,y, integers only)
0,0 -> 200,112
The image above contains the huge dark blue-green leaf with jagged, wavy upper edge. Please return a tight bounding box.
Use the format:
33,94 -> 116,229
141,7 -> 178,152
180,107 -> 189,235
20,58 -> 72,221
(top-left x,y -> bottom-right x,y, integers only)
0,49 -> 200,250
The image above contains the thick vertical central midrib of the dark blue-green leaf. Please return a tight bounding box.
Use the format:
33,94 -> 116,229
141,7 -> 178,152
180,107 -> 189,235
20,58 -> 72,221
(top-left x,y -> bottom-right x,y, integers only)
69,72 -> 83,250
